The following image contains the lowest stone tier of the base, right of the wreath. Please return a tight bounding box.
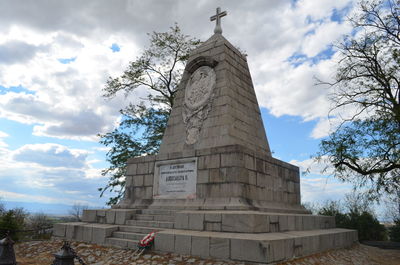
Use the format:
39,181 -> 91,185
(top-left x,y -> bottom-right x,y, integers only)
154,228 -> 357,264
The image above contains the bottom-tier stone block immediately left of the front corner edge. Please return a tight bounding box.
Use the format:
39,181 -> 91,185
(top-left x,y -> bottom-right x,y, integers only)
230,239 -> 266,263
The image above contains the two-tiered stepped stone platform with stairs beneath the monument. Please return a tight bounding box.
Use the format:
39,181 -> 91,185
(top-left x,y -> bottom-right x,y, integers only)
54,208 -> 357,264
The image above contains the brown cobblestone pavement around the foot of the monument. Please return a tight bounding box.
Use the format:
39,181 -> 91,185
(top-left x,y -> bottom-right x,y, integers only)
14,239 -> 400,265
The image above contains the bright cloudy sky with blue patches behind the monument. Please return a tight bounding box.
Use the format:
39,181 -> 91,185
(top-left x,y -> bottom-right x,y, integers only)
0,0 -> 354,213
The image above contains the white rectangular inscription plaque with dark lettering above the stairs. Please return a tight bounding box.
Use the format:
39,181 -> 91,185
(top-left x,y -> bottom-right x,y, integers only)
153,158 -> 197,199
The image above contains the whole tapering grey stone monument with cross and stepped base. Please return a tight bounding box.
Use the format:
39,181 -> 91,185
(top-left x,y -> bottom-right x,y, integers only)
54,8 -> 357,263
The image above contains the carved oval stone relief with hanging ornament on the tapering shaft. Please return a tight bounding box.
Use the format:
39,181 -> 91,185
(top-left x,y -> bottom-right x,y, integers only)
182,65 -> 216,145
